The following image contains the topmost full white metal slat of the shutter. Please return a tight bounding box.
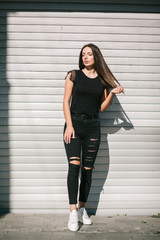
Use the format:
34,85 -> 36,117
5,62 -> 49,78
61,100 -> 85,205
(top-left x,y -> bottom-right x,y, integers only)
7,14 -> 160,27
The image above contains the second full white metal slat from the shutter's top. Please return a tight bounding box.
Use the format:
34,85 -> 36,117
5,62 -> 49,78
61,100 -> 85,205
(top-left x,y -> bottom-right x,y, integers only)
0,24 -> 160,35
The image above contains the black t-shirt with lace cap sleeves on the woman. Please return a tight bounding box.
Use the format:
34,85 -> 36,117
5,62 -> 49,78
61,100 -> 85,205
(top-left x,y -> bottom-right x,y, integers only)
65,70 -> 110,115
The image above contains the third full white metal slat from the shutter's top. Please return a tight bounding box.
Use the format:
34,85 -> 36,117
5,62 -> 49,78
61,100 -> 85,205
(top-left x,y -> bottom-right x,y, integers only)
0,32 -> 160,43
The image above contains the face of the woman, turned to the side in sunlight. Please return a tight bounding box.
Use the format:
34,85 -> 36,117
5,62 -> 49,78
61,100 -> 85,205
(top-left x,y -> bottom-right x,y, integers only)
82,47 -> 94,67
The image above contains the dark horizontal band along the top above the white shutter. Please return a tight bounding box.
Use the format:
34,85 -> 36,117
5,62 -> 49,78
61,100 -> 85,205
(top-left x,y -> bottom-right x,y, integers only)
0,1 -> 160,13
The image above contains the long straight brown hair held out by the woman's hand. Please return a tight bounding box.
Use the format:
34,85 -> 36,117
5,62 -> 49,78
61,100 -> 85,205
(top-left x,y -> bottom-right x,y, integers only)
79,43 -> 120,88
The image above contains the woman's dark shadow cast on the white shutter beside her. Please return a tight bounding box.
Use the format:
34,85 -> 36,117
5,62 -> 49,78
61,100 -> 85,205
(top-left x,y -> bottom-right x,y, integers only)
87,96 -> 134,215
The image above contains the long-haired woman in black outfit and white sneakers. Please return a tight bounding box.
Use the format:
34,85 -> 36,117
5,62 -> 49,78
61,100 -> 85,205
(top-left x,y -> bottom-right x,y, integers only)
63,43 -> 123,231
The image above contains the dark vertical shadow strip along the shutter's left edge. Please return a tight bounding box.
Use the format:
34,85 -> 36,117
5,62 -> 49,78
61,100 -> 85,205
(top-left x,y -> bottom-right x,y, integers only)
0,13 -> 10,216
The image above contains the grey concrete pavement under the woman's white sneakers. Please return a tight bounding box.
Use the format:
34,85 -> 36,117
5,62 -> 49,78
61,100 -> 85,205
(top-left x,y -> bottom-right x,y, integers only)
0,214 -> 160,240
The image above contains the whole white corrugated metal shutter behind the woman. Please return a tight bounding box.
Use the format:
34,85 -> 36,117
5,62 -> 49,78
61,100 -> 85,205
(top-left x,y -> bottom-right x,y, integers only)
0,8 -> 160,215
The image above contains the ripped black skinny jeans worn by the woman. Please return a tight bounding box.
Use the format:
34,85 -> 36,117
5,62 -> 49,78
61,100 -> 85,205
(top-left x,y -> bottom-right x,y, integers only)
63,115 -> 100,204
